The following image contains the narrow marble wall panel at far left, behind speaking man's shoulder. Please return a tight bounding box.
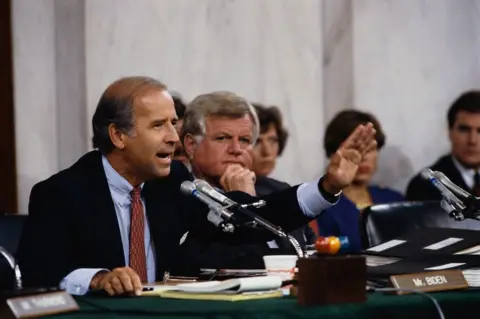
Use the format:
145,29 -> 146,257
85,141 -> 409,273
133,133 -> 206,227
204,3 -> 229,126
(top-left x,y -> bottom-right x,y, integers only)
12,0 -> 87,214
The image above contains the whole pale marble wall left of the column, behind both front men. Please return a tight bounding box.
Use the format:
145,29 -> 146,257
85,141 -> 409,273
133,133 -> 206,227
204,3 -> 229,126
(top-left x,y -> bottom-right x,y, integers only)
13,0 -> 324,212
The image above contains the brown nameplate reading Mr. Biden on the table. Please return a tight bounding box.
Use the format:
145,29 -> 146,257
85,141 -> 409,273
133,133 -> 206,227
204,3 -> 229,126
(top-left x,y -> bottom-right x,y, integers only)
390,269 -> 468,295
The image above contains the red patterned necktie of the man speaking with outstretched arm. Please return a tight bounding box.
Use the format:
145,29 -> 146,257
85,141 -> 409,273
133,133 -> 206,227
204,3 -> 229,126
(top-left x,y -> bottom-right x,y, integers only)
129,186 -> 147,282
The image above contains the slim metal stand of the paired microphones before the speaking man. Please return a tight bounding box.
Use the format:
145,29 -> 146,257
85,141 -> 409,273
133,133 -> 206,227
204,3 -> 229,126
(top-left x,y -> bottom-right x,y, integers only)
225,200 -> 305,258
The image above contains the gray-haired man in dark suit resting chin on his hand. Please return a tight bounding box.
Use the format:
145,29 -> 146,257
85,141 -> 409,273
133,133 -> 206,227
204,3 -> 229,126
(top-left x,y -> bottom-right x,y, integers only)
181,92 -> 370,269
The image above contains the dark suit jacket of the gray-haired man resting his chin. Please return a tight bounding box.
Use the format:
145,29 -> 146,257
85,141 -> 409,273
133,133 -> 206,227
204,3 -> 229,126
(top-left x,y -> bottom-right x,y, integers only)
193,177 -> 315,269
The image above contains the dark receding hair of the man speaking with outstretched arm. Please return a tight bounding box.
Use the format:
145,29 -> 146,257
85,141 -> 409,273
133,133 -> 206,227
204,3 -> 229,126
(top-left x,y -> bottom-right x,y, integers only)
92,76 -> 167,154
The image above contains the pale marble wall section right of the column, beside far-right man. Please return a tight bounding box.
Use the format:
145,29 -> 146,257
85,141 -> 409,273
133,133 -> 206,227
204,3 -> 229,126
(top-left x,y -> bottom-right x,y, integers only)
352,0 -> 480,191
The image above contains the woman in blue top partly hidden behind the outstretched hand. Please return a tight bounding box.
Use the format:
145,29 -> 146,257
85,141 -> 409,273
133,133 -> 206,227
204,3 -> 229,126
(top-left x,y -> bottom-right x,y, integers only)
316,110 -> 405,252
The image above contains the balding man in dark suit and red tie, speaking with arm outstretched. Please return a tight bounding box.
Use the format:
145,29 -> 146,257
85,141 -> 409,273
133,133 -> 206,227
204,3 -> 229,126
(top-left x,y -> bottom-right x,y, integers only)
17,77 -> 374,295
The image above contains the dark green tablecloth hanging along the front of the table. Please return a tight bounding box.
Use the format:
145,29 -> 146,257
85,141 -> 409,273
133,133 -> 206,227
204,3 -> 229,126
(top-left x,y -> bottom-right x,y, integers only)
45,290 -> 480,319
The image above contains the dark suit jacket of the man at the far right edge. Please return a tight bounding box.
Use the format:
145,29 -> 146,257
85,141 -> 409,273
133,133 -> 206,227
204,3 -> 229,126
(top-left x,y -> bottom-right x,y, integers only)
406,154 -> 471,201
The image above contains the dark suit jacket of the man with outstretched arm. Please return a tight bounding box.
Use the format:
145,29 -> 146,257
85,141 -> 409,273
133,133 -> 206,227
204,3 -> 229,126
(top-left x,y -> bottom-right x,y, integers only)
17,151 -> 308,286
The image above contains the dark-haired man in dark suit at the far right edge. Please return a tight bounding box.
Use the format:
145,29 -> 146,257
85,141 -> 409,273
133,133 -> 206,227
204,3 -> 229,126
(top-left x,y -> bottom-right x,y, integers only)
406,91 -> 480,200
